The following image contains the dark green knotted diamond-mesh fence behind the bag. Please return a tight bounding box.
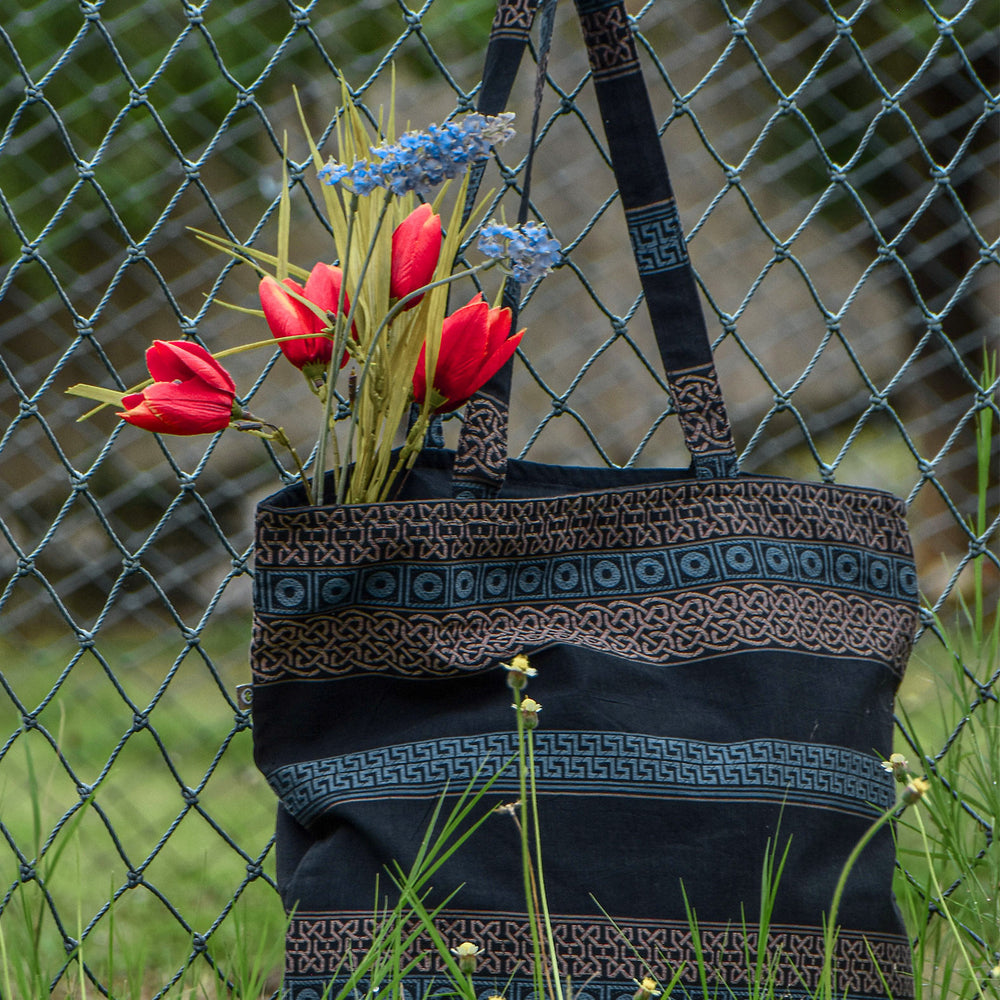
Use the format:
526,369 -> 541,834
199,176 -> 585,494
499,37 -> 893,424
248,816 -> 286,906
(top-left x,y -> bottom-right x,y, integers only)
0,0 -> 1000,996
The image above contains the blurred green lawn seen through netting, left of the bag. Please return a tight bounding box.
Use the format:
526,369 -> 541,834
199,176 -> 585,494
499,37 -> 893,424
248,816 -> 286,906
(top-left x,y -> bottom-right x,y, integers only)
0,620 -> 284,997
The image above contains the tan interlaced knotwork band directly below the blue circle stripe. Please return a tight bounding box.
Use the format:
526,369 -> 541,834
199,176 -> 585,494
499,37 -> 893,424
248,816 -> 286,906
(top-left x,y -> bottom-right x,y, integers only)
251,584 -> 918,684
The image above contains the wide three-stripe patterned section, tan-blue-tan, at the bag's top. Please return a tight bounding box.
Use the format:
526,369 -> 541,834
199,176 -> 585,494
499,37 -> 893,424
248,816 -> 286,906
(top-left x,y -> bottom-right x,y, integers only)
252,472 -> 917,684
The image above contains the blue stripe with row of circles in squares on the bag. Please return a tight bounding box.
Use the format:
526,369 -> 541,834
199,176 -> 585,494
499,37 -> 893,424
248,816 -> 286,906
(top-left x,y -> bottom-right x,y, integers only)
254,539 -> 917,616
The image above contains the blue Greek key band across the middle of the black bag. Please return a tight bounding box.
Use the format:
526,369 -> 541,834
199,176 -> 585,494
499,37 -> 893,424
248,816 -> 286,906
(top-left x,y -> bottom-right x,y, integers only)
267,730 -> 894,826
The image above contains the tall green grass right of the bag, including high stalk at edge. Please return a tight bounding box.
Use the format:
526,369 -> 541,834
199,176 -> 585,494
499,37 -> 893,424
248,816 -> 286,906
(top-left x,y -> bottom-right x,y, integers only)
896,353 -> 1000,1000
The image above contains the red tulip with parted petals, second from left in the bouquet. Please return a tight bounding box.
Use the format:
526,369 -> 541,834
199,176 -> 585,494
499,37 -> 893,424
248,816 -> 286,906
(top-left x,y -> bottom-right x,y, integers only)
259,263 -> 351,370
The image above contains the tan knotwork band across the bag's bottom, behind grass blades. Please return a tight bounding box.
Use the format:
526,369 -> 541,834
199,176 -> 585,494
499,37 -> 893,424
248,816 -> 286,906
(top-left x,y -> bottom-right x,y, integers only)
285,911 -> 913,1000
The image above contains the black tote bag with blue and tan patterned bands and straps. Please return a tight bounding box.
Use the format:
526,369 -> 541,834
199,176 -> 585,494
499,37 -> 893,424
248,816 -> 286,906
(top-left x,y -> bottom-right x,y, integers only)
251,0 -> 917,1000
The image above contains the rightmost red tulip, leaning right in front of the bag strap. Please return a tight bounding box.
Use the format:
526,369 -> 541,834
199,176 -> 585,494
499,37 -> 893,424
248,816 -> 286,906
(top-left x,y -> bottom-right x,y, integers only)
413,295 -> 524,413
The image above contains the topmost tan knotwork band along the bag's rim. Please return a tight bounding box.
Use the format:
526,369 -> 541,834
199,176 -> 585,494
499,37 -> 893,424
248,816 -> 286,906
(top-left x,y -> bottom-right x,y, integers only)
254,476 -> 912,569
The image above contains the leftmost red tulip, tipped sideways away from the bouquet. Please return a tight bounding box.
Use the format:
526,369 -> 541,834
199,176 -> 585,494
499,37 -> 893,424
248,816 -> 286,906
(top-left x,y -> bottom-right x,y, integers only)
118,340 -> 236,434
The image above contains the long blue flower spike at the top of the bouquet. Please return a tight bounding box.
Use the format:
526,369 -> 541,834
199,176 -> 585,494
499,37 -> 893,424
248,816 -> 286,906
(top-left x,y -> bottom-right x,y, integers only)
319,112 -> 514,195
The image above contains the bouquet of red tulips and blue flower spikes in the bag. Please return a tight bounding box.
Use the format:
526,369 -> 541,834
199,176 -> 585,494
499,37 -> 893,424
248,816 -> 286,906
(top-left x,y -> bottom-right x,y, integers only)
68,89 -> 559,505
